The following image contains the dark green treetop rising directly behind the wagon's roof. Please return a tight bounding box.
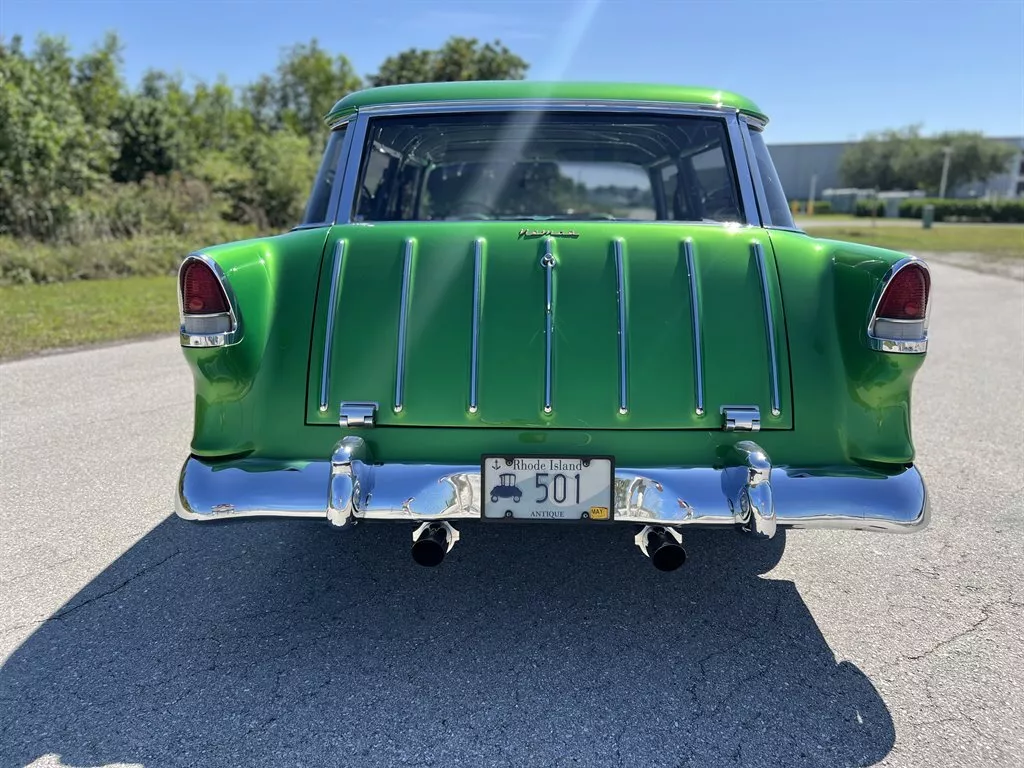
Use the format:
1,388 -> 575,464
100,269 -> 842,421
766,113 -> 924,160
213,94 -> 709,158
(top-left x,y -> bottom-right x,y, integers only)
367,37 -> 529,86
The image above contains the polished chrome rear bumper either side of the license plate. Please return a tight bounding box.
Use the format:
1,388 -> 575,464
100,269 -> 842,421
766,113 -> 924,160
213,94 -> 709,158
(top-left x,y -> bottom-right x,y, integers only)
176,436 -> 930,538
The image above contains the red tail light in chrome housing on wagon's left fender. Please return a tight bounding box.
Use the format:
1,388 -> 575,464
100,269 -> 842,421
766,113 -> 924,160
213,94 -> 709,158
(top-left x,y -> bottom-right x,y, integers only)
178,256 -> 237,347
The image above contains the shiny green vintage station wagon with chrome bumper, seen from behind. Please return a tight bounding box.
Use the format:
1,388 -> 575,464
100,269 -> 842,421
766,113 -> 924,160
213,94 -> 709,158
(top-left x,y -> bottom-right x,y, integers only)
176,81 -> 931,570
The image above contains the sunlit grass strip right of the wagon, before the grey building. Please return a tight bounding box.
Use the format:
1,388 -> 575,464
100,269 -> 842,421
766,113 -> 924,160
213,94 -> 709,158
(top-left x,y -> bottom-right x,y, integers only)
807,222 -> 1024,259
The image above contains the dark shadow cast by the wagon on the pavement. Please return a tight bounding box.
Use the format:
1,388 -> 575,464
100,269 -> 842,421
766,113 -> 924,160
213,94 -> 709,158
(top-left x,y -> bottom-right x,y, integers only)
0,518 -> 895,766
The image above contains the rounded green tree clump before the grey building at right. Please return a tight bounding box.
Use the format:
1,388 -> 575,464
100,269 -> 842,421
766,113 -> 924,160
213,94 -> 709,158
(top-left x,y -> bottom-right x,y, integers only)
840,125 -> 1014,195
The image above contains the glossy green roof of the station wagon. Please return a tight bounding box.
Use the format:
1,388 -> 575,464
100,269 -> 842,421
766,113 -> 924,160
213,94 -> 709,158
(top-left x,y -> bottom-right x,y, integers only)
327,80 -> 767,123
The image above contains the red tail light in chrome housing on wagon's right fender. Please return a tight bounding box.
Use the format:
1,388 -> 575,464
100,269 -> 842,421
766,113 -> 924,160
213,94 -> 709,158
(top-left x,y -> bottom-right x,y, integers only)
867,258 -> 932,352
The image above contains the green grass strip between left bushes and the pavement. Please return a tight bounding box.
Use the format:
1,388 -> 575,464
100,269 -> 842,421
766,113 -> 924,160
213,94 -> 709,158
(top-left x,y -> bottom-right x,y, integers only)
0,276 -> 178,359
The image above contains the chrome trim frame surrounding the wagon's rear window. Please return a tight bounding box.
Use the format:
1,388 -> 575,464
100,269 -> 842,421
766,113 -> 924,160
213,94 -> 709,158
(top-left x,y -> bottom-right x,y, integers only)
332,98 -> 764,226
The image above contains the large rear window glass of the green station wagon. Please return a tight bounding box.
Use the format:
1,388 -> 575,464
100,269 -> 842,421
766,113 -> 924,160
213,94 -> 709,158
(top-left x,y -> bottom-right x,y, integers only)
353,112 -> 741,222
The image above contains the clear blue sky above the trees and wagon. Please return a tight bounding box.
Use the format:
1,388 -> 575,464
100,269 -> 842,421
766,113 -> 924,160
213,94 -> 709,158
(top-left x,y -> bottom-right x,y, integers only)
0,0 -> 1024,143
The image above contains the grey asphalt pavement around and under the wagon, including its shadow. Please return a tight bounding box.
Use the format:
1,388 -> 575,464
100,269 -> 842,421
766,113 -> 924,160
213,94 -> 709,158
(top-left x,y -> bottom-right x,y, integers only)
0,265 -> 1024,767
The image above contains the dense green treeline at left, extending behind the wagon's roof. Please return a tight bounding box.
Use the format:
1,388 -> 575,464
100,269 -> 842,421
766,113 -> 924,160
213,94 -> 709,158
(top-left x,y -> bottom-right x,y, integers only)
0,33 -> 527,243
